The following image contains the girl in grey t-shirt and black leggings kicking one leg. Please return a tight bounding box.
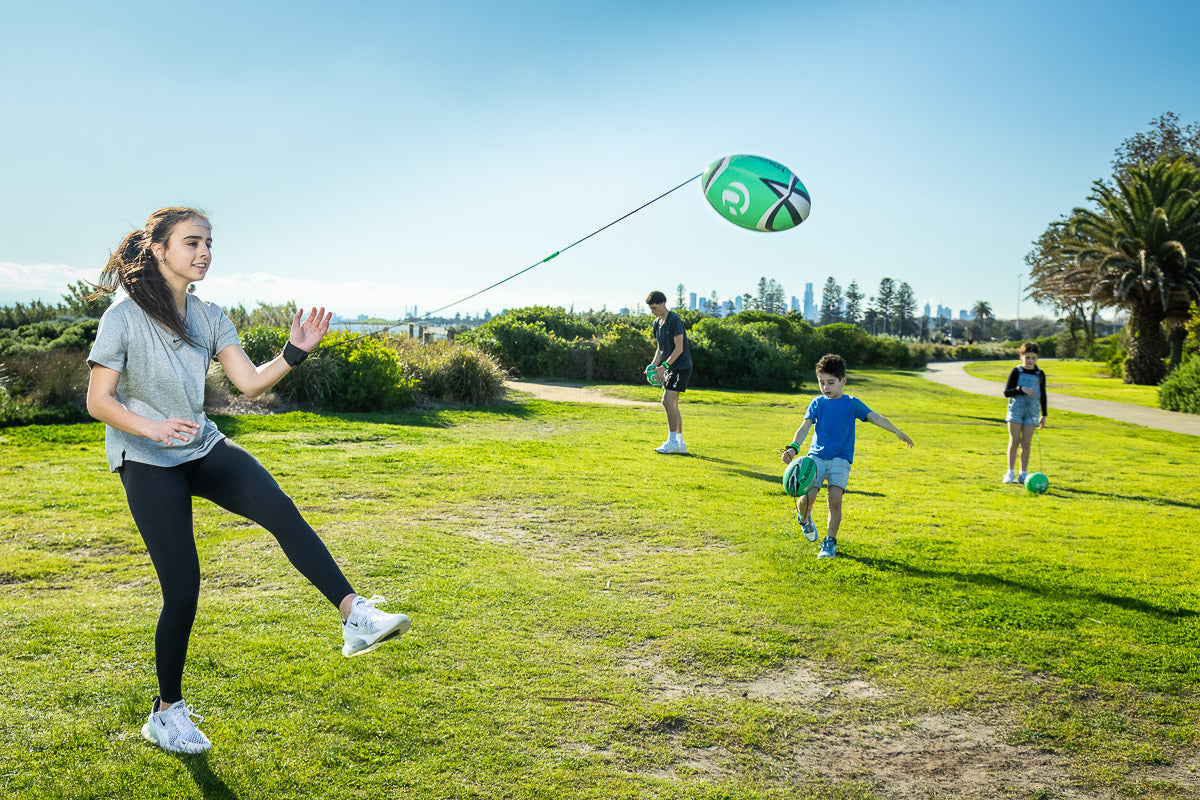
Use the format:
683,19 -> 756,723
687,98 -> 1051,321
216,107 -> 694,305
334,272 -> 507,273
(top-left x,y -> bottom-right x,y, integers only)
88,207 -> 409,753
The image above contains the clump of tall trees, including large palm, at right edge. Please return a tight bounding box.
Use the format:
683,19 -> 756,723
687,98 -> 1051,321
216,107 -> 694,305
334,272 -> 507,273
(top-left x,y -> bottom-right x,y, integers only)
1025,112 -> 1200,385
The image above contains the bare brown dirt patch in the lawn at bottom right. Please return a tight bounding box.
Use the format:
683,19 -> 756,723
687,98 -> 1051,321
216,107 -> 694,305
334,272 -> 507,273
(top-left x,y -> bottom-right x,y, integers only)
606,654 -> 1200,800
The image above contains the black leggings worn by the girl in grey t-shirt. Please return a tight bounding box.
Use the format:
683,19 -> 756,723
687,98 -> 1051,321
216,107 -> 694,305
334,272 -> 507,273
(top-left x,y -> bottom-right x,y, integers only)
120,439 -> 354,704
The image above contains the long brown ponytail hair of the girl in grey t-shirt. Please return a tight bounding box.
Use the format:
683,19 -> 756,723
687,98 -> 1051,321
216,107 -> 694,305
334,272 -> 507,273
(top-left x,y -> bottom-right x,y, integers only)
91,206 -> 209,344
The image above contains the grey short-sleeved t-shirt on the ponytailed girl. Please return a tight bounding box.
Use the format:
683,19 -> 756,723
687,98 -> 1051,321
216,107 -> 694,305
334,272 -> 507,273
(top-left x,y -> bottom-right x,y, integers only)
88,295 -> 238,473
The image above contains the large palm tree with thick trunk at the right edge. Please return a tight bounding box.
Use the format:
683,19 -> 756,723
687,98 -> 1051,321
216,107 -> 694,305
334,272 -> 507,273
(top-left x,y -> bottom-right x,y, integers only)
1063,158 -> 1200,385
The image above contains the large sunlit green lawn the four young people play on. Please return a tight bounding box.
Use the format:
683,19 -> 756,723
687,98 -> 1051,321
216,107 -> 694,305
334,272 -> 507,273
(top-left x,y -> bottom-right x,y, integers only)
0,368 -> 1200,800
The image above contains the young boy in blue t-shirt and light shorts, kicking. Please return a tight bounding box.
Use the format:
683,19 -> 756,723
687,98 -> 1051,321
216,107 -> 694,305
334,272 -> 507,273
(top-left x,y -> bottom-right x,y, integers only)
782,353 -> 912,558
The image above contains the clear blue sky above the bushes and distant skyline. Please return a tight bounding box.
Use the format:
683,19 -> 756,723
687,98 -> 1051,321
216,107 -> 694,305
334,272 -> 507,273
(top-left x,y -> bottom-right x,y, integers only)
0,0 -> 1200,317
